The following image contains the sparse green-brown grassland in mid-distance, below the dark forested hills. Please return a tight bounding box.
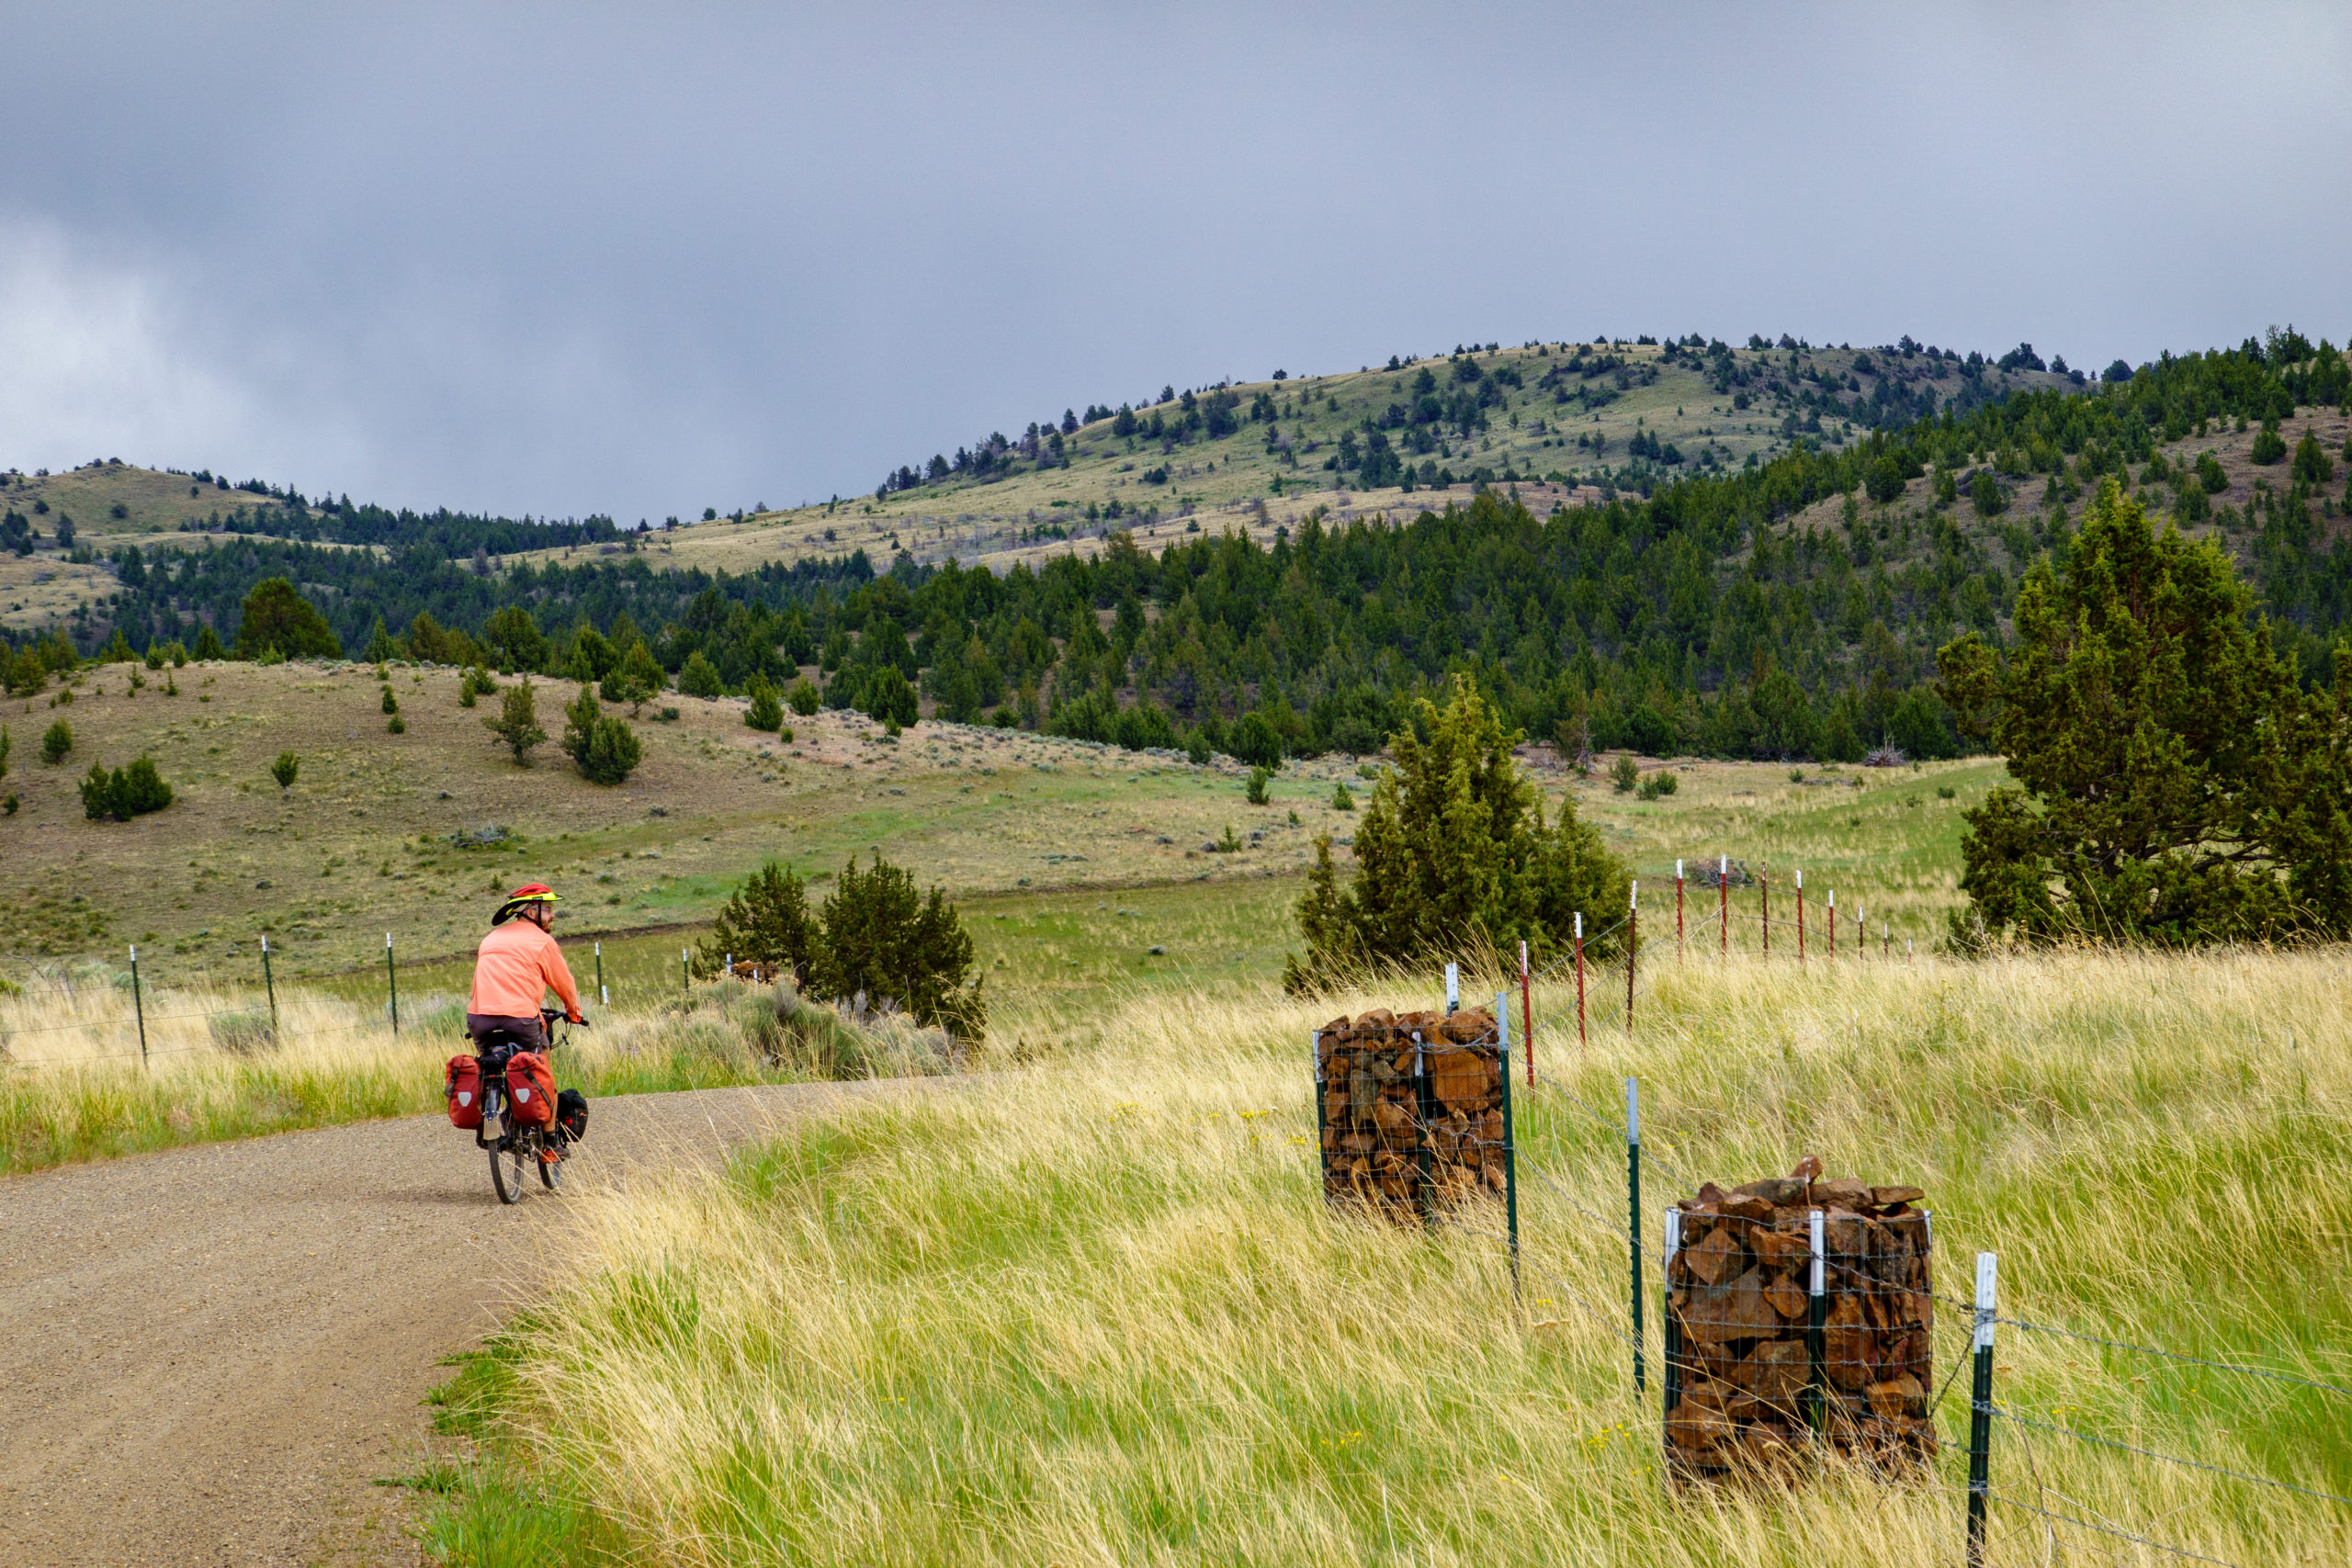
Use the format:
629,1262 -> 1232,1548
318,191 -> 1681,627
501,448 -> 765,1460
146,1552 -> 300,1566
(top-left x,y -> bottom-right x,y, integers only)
0,663 -> 1999,985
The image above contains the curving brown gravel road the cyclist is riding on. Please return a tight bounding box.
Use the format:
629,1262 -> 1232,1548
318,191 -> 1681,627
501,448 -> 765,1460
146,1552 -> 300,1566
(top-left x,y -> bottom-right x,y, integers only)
0,1084 -> 935,1568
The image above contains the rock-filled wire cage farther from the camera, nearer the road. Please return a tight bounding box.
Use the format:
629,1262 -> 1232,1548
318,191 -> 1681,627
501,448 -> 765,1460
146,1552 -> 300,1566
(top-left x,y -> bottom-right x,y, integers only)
1315,1009 -> 1517,1223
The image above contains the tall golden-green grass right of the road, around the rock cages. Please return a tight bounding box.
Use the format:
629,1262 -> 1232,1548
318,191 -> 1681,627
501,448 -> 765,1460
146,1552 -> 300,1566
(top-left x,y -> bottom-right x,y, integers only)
430,952 -> 2352,1568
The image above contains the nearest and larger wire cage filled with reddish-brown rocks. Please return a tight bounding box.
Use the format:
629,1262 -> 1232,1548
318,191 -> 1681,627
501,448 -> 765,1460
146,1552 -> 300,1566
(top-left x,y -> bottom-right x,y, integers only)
1665,1159 -> 1936,1479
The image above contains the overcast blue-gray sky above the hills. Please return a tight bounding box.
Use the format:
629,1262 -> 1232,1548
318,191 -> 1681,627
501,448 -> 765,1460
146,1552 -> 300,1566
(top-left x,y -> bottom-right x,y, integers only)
0,0 -> 2352,522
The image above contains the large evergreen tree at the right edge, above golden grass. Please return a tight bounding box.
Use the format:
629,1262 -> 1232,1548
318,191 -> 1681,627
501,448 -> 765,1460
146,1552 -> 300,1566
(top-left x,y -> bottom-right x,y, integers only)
1938,479 -> 2352,945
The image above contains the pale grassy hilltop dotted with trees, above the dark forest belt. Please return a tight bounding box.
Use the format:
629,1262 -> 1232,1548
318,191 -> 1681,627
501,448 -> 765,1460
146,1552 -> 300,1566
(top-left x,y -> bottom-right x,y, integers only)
496,341 -> 2075,571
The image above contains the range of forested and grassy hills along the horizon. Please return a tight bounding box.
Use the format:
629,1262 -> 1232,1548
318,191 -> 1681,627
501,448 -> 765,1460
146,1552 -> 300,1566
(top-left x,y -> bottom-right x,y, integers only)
0,332 -> 2352,789
